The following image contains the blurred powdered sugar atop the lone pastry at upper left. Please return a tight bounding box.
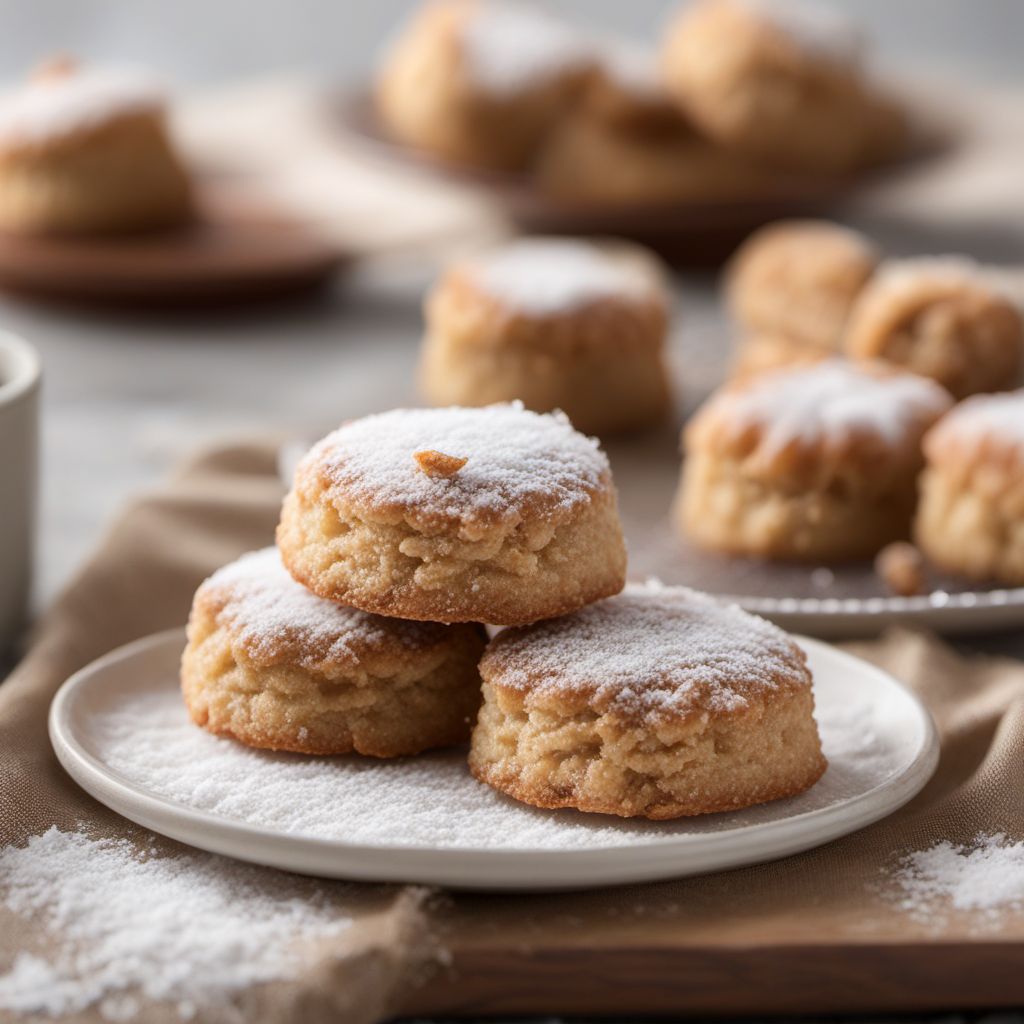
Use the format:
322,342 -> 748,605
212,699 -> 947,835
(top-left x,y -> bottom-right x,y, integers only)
0,69 -> 164,144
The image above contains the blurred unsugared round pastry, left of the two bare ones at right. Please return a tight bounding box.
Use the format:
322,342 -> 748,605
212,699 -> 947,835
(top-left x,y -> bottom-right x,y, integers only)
725,220 -> 879,353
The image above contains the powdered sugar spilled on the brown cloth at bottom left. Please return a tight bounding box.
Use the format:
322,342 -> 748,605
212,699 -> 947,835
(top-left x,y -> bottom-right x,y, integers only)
0,827 -> 348,1020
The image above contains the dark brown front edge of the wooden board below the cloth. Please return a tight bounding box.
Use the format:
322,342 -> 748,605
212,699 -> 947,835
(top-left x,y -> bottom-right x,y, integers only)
397,936 -> 1024,1018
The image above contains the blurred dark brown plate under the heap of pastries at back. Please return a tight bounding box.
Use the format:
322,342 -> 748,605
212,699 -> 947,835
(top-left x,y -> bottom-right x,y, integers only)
335,89 -> 955,266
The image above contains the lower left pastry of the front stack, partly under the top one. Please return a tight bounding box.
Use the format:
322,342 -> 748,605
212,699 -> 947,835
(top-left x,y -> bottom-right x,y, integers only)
181,548 -> 485,758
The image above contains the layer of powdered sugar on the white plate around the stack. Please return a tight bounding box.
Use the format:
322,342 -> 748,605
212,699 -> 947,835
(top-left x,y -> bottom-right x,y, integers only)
83,663 -> 907,850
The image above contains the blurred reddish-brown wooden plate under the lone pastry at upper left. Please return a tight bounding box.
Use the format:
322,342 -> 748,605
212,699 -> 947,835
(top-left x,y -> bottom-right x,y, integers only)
0,184 -> 346,306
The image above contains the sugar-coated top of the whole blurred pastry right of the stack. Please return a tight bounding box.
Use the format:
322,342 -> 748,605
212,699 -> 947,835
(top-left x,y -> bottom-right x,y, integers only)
700,359 -> 951,454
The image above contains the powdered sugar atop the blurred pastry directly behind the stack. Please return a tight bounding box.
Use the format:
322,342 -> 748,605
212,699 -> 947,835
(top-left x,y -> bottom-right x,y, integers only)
468,239 -> 652,315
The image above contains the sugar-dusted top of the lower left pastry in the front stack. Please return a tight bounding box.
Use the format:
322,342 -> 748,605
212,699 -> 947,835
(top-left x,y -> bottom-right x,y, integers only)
197,548 -> 445,670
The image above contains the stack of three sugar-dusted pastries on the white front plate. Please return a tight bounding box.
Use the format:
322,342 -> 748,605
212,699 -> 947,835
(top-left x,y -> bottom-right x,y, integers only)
181,403 -> 824,818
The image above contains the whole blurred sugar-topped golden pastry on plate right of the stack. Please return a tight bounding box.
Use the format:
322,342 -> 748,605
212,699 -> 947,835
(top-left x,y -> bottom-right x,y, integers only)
675,359 -> 950,562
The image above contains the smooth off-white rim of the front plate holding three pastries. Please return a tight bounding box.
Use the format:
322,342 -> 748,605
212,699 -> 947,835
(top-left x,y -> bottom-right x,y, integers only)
47,627 -> 940,890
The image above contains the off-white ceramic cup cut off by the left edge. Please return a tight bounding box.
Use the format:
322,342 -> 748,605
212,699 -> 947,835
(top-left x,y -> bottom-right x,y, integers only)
0,331 -> 41,655
